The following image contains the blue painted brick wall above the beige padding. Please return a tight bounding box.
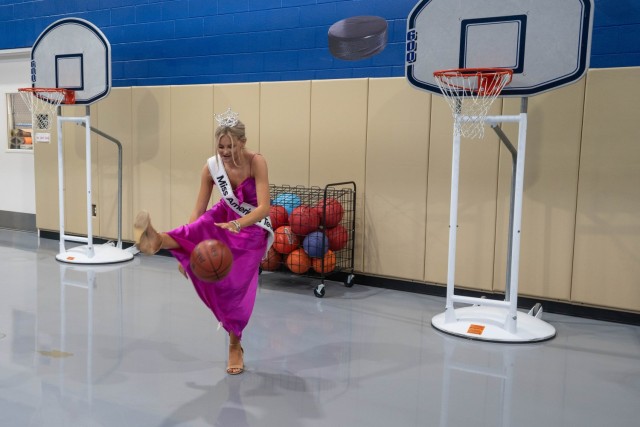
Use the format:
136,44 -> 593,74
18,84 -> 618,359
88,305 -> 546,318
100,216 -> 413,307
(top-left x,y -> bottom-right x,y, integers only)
0,0 -> 640,86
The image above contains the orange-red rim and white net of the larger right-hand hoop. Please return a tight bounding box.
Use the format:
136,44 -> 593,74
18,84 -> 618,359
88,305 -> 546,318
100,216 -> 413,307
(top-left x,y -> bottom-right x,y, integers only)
433,68 -> 513,138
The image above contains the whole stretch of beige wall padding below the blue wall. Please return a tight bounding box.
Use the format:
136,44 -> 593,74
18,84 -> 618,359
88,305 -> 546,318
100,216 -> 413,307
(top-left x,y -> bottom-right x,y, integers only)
35,68 -> 640,312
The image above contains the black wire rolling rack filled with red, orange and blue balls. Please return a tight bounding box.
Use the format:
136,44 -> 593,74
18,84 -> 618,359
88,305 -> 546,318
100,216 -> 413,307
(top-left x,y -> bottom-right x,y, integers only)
261,181 -> 356,298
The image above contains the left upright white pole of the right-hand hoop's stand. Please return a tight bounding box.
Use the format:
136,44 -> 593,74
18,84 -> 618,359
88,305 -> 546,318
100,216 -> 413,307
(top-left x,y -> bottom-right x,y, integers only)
445,122 -> 460,323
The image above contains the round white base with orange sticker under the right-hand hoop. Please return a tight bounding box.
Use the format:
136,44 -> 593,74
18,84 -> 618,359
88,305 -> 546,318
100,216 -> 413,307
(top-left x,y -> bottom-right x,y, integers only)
431,305 -> 556,343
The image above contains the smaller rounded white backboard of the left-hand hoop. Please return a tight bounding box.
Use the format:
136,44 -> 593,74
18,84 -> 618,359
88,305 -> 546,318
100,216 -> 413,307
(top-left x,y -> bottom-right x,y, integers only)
31,18 -> 111,104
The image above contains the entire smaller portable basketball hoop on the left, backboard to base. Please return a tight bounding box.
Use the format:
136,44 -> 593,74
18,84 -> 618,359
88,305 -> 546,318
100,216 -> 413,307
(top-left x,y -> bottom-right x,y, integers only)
25,18 -> 137,265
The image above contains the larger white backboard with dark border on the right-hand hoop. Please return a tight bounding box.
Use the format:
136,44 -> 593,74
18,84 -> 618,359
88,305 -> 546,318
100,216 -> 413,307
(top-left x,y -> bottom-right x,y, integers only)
406,0 -> 593,97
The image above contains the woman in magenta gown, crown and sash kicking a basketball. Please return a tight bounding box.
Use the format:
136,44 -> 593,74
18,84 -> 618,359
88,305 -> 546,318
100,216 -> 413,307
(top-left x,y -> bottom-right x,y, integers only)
134,109 -> 273,375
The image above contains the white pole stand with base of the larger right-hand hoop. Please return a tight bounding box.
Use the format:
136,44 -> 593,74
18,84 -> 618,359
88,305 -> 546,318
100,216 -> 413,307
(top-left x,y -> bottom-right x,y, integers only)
431,98 -> 556,343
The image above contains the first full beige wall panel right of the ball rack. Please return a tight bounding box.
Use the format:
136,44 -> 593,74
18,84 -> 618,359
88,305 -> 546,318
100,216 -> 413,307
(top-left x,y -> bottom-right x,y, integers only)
364,79 -> 431,280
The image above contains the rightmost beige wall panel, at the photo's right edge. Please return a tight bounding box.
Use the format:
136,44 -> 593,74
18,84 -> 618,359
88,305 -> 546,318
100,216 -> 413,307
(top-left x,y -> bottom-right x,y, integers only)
571,67 -> 640,311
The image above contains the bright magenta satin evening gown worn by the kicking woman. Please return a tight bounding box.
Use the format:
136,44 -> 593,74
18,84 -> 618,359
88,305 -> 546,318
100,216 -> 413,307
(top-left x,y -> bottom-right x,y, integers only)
167,177 -> 267,338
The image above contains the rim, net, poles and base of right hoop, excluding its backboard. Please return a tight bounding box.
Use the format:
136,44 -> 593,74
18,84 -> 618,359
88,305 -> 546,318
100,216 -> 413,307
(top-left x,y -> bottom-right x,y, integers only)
431,68 -> 556,343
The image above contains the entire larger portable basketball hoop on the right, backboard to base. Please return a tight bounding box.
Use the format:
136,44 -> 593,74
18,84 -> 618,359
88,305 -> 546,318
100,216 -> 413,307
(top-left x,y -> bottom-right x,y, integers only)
405,0 -> 595,343
